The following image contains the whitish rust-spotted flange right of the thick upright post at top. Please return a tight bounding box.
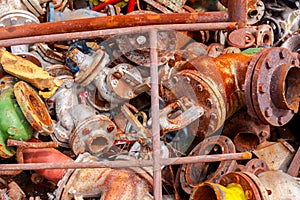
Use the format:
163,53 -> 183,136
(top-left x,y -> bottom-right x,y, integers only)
247,0 -> 265,25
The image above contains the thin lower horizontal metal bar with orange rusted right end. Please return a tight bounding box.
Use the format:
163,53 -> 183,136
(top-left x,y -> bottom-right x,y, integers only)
0,152 -> 252,171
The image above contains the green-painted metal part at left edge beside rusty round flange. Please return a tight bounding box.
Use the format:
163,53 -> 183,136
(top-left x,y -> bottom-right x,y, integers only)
0,88 -> 34,158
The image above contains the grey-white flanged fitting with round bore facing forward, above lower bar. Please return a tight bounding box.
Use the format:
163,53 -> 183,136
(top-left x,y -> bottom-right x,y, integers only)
69,104 -> 117,156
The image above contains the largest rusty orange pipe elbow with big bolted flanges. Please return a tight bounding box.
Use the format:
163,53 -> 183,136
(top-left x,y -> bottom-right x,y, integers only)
161,47 -> 300,137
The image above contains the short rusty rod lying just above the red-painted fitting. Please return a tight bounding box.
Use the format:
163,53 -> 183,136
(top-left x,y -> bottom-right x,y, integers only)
6,139 -> 58,149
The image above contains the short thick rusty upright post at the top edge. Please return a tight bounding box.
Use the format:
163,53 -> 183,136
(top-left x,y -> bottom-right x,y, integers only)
228,0 -> 249,28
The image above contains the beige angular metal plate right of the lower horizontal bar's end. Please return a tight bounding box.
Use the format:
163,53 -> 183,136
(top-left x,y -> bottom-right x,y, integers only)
253,141 -> 295,172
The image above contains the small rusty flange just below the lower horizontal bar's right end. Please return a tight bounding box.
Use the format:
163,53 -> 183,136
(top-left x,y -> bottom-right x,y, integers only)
242,158 -> 270,176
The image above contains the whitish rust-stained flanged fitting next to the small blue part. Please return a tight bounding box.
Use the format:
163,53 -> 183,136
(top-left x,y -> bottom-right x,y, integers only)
68,48 -> 110,86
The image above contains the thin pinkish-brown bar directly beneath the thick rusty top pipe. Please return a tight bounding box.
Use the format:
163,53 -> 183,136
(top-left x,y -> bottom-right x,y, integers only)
0,22 -> 236,47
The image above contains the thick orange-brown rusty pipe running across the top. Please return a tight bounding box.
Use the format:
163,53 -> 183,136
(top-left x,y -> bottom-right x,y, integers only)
0,12 -> 229,39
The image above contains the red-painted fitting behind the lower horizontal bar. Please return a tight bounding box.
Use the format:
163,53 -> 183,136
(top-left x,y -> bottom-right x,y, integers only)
22,148 -> 73,184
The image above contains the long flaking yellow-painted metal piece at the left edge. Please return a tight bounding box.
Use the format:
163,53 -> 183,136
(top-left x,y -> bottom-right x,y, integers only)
0,50 -> 62,90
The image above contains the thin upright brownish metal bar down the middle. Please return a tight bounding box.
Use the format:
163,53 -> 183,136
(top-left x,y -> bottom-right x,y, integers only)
149,29 -> 162,200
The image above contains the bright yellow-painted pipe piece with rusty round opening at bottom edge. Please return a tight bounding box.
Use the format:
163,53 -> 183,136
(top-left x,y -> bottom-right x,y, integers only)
190,182 -> 248,200
